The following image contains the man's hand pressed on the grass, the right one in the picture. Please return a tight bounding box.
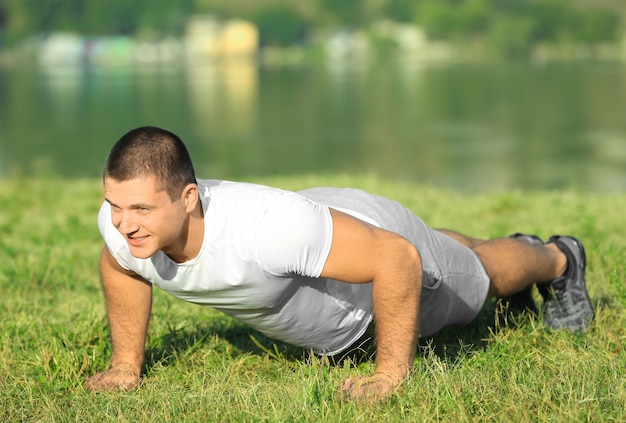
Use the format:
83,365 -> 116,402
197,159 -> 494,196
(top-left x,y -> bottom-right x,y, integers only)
339,373 -> 402,404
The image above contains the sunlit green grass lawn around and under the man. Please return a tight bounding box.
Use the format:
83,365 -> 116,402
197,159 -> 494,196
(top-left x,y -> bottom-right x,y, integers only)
0,176 -> 626,422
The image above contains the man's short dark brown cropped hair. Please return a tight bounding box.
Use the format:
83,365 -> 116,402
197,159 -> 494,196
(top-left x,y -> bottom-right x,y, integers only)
103,126 -> 196,201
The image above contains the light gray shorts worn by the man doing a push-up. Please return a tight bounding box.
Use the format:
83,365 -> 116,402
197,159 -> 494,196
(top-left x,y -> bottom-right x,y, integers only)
301,188 -> 489,337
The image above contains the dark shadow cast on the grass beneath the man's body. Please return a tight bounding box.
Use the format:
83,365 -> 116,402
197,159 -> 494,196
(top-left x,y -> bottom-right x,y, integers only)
144,302 -> 529,372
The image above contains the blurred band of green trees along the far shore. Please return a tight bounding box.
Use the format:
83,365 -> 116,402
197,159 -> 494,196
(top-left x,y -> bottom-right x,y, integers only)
0,0 -> 626,56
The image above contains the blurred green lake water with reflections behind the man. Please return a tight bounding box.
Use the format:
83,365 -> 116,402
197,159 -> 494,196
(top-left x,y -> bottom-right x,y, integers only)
0,62 -> 626,191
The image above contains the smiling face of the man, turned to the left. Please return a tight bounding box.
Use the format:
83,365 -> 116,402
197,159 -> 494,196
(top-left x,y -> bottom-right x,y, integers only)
104,176 -> 188,258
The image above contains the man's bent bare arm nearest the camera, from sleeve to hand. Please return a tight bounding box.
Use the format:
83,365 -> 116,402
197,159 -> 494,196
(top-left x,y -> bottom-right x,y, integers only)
321,209 -> 422,400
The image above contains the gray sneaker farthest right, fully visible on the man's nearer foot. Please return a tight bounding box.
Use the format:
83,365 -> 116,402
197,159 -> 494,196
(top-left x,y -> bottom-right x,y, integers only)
537,235 -> 593,332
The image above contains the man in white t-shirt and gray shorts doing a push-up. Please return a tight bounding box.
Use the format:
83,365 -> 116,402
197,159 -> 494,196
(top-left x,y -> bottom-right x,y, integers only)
87,127 -> 593,400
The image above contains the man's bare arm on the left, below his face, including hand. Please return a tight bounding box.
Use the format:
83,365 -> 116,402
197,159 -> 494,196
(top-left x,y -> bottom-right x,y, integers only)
86,247 -> 152,391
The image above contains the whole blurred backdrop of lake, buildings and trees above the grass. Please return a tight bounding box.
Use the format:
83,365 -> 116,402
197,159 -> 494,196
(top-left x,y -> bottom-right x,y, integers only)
0,0 -> 626,192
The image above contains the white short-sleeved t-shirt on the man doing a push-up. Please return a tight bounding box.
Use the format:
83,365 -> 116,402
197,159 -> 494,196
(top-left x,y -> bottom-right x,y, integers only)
98,180 -> 375,355
